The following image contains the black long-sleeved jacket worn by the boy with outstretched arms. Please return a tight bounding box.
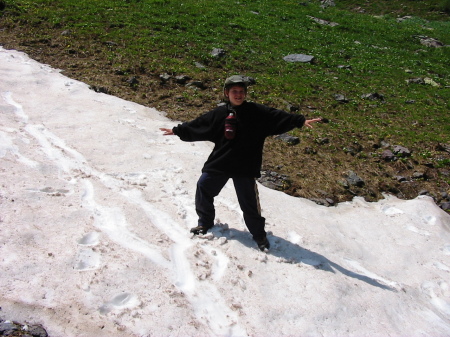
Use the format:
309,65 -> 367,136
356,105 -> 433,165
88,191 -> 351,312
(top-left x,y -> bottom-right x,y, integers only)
173,102 -> 305,177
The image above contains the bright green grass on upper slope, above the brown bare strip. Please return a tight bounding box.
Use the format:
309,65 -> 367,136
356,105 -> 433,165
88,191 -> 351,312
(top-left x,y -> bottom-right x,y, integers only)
2,0 -> 450,139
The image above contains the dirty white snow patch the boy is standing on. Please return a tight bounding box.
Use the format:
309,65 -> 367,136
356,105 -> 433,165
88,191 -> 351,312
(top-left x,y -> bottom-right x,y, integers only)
0,47 -> 450,337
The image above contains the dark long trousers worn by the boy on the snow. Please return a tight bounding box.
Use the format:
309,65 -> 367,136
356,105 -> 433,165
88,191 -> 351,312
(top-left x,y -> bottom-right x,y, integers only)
195,173 -> 266,238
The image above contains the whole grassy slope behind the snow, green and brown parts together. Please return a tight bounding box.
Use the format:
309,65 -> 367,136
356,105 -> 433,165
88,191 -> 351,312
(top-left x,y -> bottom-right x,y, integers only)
0,0 -> 450,205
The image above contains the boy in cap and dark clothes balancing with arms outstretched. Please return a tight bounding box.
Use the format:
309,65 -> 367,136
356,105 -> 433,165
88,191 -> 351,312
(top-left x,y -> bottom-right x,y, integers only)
160,75 -> 322,251
